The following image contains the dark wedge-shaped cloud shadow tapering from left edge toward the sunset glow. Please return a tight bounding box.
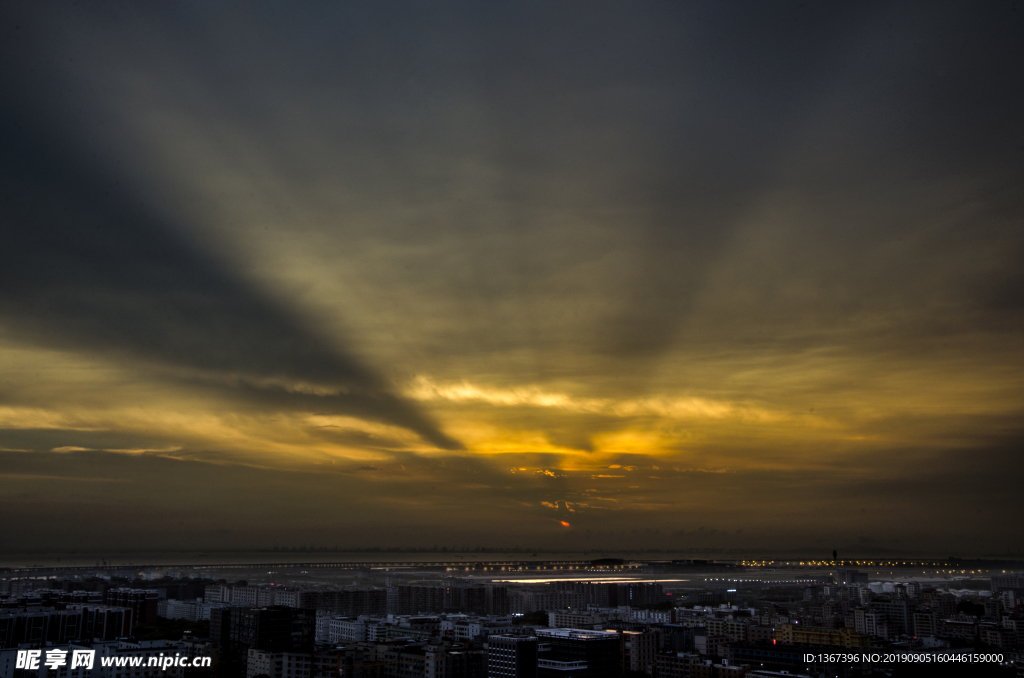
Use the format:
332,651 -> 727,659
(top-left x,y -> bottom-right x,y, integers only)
0,95 -> 458,449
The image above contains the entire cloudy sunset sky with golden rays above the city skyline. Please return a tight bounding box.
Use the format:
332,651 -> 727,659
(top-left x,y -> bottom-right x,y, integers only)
0,1 -> 1024,556
